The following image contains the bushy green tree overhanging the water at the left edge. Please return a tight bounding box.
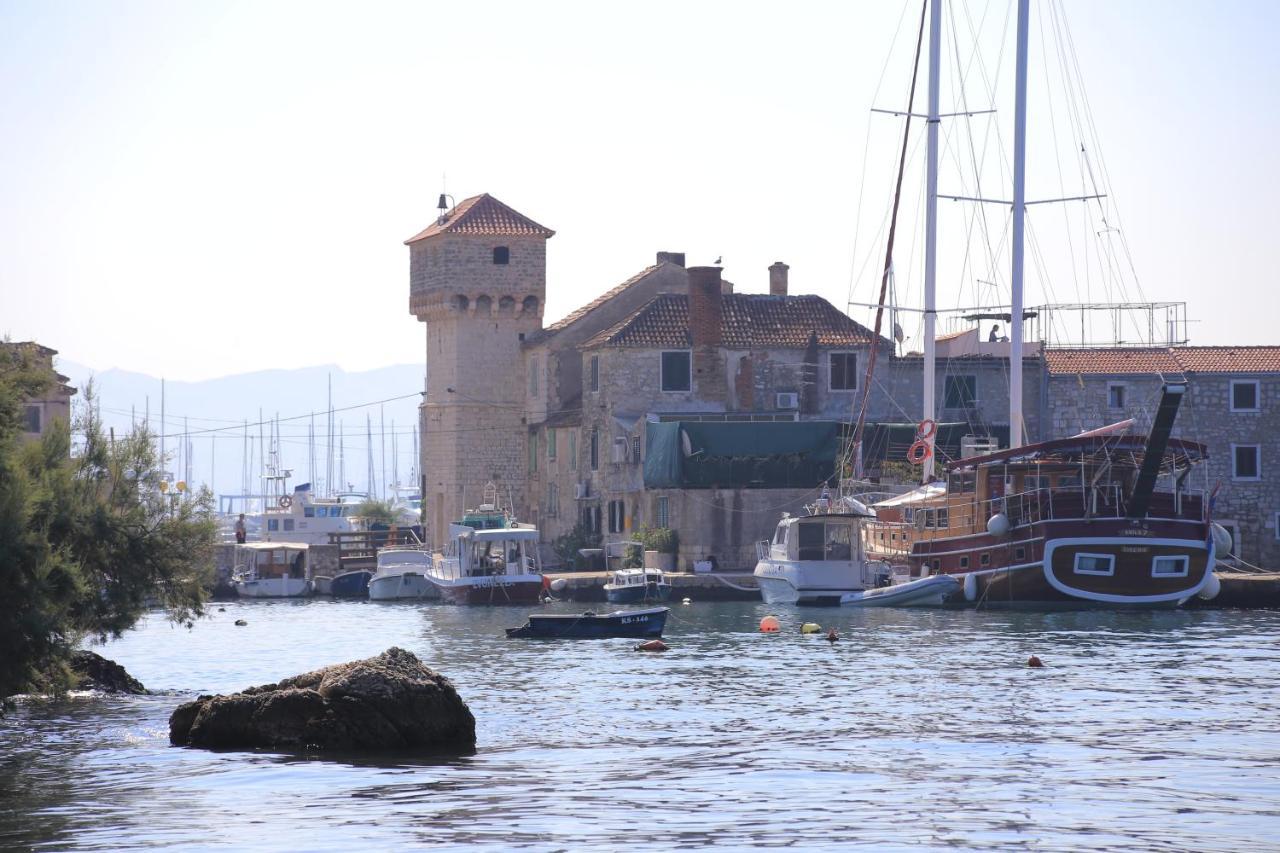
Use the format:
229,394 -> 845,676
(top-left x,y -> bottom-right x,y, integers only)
0,347 -> 216,698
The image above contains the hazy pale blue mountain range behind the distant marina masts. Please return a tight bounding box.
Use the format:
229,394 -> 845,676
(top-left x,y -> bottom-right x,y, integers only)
56,359 -> 424,494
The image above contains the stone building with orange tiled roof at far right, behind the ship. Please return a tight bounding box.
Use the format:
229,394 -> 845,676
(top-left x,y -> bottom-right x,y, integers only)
1043,346 -> 1280,569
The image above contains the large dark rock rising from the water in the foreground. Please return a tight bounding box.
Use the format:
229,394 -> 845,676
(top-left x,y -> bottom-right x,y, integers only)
169,648 -> 476,753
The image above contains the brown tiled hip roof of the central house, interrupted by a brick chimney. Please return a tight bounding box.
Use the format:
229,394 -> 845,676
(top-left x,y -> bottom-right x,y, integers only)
582,293 -> 890,350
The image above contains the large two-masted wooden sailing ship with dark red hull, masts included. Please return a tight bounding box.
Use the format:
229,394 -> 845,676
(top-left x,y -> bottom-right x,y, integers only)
851,0 -> 1217,608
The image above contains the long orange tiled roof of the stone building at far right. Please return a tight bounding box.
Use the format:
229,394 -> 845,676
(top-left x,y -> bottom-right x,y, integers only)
1044,347 -> 1280,375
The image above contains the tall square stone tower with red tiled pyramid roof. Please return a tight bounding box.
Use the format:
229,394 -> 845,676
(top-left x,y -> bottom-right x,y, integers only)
404,193 -> 556,546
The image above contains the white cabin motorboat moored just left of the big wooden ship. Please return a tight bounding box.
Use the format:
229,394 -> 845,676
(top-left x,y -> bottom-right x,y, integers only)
753,488 -> 890,606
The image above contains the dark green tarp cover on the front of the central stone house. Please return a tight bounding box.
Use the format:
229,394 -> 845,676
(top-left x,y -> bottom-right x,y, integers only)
644,421 -> 841,489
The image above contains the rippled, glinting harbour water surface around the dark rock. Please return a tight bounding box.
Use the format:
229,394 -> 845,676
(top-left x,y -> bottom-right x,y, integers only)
0,601 -> 1280,850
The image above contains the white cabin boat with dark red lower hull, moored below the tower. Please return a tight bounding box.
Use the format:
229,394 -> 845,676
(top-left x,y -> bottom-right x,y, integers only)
424,521 -> 543,605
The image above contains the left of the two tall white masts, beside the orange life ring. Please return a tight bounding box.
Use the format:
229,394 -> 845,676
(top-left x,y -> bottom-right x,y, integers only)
920,0 -> 942,483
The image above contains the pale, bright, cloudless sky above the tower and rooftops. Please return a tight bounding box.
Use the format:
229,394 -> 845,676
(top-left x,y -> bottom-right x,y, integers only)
0,0 -> 1280,380
